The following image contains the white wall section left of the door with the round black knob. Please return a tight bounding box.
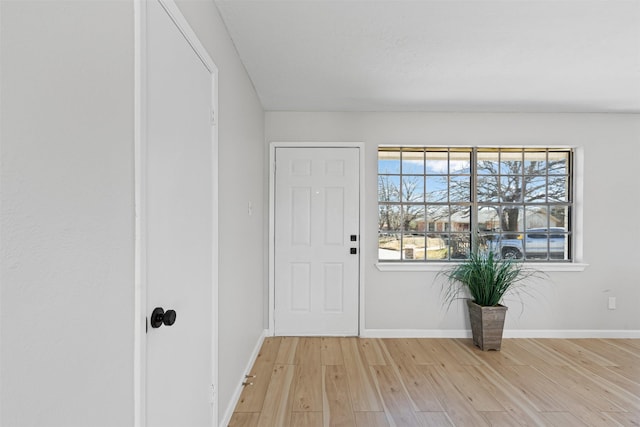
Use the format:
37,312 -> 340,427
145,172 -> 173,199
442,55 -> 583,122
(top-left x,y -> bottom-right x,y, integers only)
0,1 -> 134,427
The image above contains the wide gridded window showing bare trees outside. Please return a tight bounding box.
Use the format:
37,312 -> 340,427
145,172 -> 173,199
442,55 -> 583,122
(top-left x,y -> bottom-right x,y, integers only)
378,147 -> 573,262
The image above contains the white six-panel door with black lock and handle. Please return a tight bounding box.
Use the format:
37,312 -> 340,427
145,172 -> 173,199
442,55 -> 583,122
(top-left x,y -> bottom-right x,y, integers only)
274,147 -> 360,335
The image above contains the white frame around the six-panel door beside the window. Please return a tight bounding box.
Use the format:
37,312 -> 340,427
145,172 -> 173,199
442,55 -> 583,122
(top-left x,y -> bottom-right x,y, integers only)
268,142 -> 366,336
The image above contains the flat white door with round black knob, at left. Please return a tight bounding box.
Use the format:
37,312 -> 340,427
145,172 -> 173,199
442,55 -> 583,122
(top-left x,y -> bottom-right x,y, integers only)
141,0 -> 217,427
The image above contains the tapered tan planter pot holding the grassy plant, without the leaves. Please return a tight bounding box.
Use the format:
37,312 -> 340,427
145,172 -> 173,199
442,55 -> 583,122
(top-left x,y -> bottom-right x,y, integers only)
467,300 -> 507,351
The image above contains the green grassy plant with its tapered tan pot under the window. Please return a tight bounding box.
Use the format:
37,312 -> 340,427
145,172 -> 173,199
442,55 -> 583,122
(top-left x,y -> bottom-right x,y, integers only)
438,251 -> 537,351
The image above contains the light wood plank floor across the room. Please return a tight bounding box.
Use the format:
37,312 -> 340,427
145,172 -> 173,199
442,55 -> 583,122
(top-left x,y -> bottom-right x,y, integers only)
230,337 -> 640,427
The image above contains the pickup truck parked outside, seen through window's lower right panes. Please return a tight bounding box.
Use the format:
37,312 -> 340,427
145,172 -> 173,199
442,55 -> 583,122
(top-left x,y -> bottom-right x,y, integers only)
494,227 -> 567,259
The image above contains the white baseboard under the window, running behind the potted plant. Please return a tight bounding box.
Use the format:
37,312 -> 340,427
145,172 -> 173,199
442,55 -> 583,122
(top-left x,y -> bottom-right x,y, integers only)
360,329 -> 640,338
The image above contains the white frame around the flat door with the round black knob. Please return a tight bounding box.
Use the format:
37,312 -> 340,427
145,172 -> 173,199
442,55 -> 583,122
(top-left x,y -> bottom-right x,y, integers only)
133,0 -> 219,427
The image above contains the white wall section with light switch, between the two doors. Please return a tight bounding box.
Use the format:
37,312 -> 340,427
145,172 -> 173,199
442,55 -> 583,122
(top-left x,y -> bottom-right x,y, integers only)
178,0 -> 267,424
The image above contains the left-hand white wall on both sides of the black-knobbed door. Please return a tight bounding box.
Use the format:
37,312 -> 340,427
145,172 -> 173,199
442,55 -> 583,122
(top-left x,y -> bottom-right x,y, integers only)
0,0 -> 266,427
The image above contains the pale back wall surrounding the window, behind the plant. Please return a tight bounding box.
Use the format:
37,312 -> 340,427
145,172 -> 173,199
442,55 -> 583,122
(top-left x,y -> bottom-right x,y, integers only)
266,112 -> 640,336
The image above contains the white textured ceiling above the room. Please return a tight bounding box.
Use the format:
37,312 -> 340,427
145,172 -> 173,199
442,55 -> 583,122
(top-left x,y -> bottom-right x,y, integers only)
216,0 -> 640,113
